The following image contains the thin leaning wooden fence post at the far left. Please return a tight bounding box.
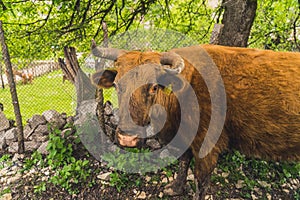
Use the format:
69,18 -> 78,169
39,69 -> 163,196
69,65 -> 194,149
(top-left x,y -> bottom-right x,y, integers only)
0,20 -> 25,153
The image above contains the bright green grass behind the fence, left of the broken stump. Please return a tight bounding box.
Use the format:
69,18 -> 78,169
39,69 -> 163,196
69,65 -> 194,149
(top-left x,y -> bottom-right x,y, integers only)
0,70 -> 76,123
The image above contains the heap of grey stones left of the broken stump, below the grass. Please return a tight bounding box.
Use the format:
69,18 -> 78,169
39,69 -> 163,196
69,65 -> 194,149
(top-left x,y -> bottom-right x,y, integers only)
0,110 -> 74,154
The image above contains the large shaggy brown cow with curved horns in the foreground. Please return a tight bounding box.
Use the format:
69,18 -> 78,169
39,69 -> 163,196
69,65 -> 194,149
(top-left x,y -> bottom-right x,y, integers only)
92,43 -> 300,198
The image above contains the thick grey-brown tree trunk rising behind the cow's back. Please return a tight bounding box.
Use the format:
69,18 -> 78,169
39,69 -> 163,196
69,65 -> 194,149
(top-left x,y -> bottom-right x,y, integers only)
218,0 -> 257,47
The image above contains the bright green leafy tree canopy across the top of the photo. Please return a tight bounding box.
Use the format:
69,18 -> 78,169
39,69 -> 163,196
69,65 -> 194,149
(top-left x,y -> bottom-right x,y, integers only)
0,0 -> 300,61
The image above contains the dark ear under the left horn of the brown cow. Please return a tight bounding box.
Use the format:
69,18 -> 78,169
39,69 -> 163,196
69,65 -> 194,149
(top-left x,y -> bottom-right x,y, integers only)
91,69 -> 118,88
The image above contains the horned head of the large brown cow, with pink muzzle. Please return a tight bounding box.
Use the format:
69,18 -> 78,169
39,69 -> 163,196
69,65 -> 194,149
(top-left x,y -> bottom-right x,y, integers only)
91,39 -> 185,147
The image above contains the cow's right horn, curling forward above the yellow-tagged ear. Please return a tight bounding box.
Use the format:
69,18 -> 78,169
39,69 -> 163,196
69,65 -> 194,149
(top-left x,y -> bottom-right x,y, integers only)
160,52 -> 184,74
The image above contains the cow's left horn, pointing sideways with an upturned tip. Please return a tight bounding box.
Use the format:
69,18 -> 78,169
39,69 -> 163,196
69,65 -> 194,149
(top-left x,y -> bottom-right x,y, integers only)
91,40 -> 127,60
